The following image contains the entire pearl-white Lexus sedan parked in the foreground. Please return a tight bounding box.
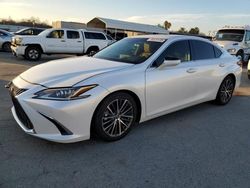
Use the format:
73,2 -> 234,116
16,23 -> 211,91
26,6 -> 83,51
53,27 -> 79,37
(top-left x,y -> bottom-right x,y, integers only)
6,35 -> 242,143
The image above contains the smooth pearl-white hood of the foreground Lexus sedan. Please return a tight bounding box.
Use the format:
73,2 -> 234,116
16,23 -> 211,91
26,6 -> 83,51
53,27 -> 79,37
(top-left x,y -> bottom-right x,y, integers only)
20,57 -> 133,87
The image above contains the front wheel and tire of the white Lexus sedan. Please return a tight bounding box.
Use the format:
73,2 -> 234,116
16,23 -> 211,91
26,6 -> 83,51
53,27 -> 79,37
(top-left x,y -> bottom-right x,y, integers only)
92,92 -> 138,141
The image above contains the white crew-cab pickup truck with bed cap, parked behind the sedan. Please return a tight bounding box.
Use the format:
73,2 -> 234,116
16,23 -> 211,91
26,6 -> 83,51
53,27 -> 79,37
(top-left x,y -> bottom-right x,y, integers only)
11,29 -> 115,61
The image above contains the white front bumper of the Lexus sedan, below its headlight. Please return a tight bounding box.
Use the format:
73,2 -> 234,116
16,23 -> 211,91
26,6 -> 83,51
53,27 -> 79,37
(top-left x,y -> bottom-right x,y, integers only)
10,77 -> 107,143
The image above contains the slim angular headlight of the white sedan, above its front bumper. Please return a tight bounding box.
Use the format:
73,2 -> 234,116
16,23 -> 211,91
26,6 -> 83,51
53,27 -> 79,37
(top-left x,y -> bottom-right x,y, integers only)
33,85 -> 97,101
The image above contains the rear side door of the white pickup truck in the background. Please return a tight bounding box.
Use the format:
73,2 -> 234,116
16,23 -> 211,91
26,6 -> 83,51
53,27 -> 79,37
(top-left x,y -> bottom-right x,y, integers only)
66,30 -> 83,53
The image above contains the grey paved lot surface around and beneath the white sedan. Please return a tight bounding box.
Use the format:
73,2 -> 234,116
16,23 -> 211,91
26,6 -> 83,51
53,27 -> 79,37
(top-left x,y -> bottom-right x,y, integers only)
0,52 -> 250,188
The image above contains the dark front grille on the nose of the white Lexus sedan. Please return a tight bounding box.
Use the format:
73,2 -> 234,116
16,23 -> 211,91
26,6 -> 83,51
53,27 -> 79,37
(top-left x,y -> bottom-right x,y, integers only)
9,83 -> 34,129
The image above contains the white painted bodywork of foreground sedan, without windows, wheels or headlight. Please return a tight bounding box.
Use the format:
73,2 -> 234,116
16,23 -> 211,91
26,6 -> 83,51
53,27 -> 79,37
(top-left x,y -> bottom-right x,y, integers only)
9,35 -> 242,143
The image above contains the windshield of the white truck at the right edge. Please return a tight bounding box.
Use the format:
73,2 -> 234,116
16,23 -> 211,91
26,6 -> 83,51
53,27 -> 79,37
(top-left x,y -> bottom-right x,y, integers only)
216,29 -> 245,42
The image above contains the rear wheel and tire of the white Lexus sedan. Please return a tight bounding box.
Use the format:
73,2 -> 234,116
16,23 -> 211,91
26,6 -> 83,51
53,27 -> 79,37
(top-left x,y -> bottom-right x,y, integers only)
215,76 -> 235,105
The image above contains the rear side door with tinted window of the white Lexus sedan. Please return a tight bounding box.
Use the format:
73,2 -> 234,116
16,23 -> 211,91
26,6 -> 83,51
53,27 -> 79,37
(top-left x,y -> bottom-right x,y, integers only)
190,40 -> 223,100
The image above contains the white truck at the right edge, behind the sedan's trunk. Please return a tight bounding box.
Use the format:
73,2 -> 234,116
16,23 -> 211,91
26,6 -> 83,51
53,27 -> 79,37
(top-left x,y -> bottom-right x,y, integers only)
214,26 -> 250,62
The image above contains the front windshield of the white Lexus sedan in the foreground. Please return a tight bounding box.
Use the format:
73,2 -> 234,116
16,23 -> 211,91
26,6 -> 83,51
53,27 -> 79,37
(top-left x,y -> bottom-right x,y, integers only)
94,38 -> 166,64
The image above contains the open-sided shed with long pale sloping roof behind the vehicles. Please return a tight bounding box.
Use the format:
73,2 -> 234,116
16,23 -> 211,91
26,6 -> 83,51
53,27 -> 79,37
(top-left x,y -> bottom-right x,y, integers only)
87,17 -> 169,40
